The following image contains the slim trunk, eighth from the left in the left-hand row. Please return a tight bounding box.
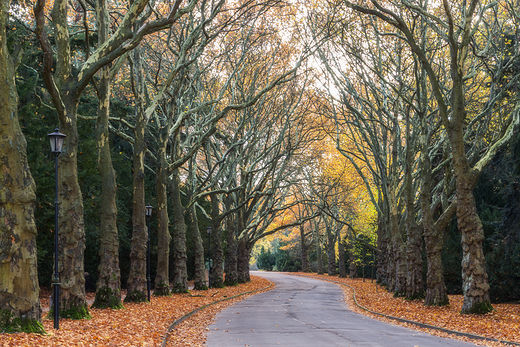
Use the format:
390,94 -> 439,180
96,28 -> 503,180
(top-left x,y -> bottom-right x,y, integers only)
211,194 -> 224,288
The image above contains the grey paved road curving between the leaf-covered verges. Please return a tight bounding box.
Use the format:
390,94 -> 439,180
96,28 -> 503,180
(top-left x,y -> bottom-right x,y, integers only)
207,272 -> 475,347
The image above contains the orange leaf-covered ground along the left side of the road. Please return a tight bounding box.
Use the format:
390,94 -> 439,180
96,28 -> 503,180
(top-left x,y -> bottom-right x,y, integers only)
0,276 -> 274,347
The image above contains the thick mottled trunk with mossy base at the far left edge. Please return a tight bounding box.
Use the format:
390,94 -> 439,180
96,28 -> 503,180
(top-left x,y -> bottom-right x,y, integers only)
0,10 -> 45,333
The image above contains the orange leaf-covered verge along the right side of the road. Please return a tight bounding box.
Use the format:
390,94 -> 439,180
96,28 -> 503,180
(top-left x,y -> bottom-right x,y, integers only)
294,272 -> 520,346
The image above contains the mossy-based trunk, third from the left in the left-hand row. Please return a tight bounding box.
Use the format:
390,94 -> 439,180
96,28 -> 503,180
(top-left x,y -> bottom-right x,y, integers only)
93,64 -> 122,308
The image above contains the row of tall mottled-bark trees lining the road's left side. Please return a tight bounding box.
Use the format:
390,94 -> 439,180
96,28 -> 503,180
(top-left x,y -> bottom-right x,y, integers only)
0,0 -> 320,331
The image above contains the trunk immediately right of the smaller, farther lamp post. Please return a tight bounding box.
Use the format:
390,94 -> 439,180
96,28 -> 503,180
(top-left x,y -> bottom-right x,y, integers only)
154,156 -> 171,295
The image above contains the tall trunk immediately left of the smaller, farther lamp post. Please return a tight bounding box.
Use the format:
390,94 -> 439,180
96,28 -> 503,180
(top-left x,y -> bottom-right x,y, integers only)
125,48 -> 148,302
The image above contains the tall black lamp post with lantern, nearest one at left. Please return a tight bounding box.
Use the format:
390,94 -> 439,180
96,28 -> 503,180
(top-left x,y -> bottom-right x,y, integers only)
47,128 -> 67,329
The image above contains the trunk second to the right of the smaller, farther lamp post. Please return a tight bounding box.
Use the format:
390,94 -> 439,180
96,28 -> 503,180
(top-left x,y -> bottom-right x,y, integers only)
170,169 -> 188,293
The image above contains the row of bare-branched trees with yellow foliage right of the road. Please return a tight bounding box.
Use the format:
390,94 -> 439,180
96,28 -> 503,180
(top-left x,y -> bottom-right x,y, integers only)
308,0 -> 520,313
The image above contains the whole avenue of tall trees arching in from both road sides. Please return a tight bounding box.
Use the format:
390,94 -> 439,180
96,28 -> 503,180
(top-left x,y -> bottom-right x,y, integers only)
0,0 -> 520,333
